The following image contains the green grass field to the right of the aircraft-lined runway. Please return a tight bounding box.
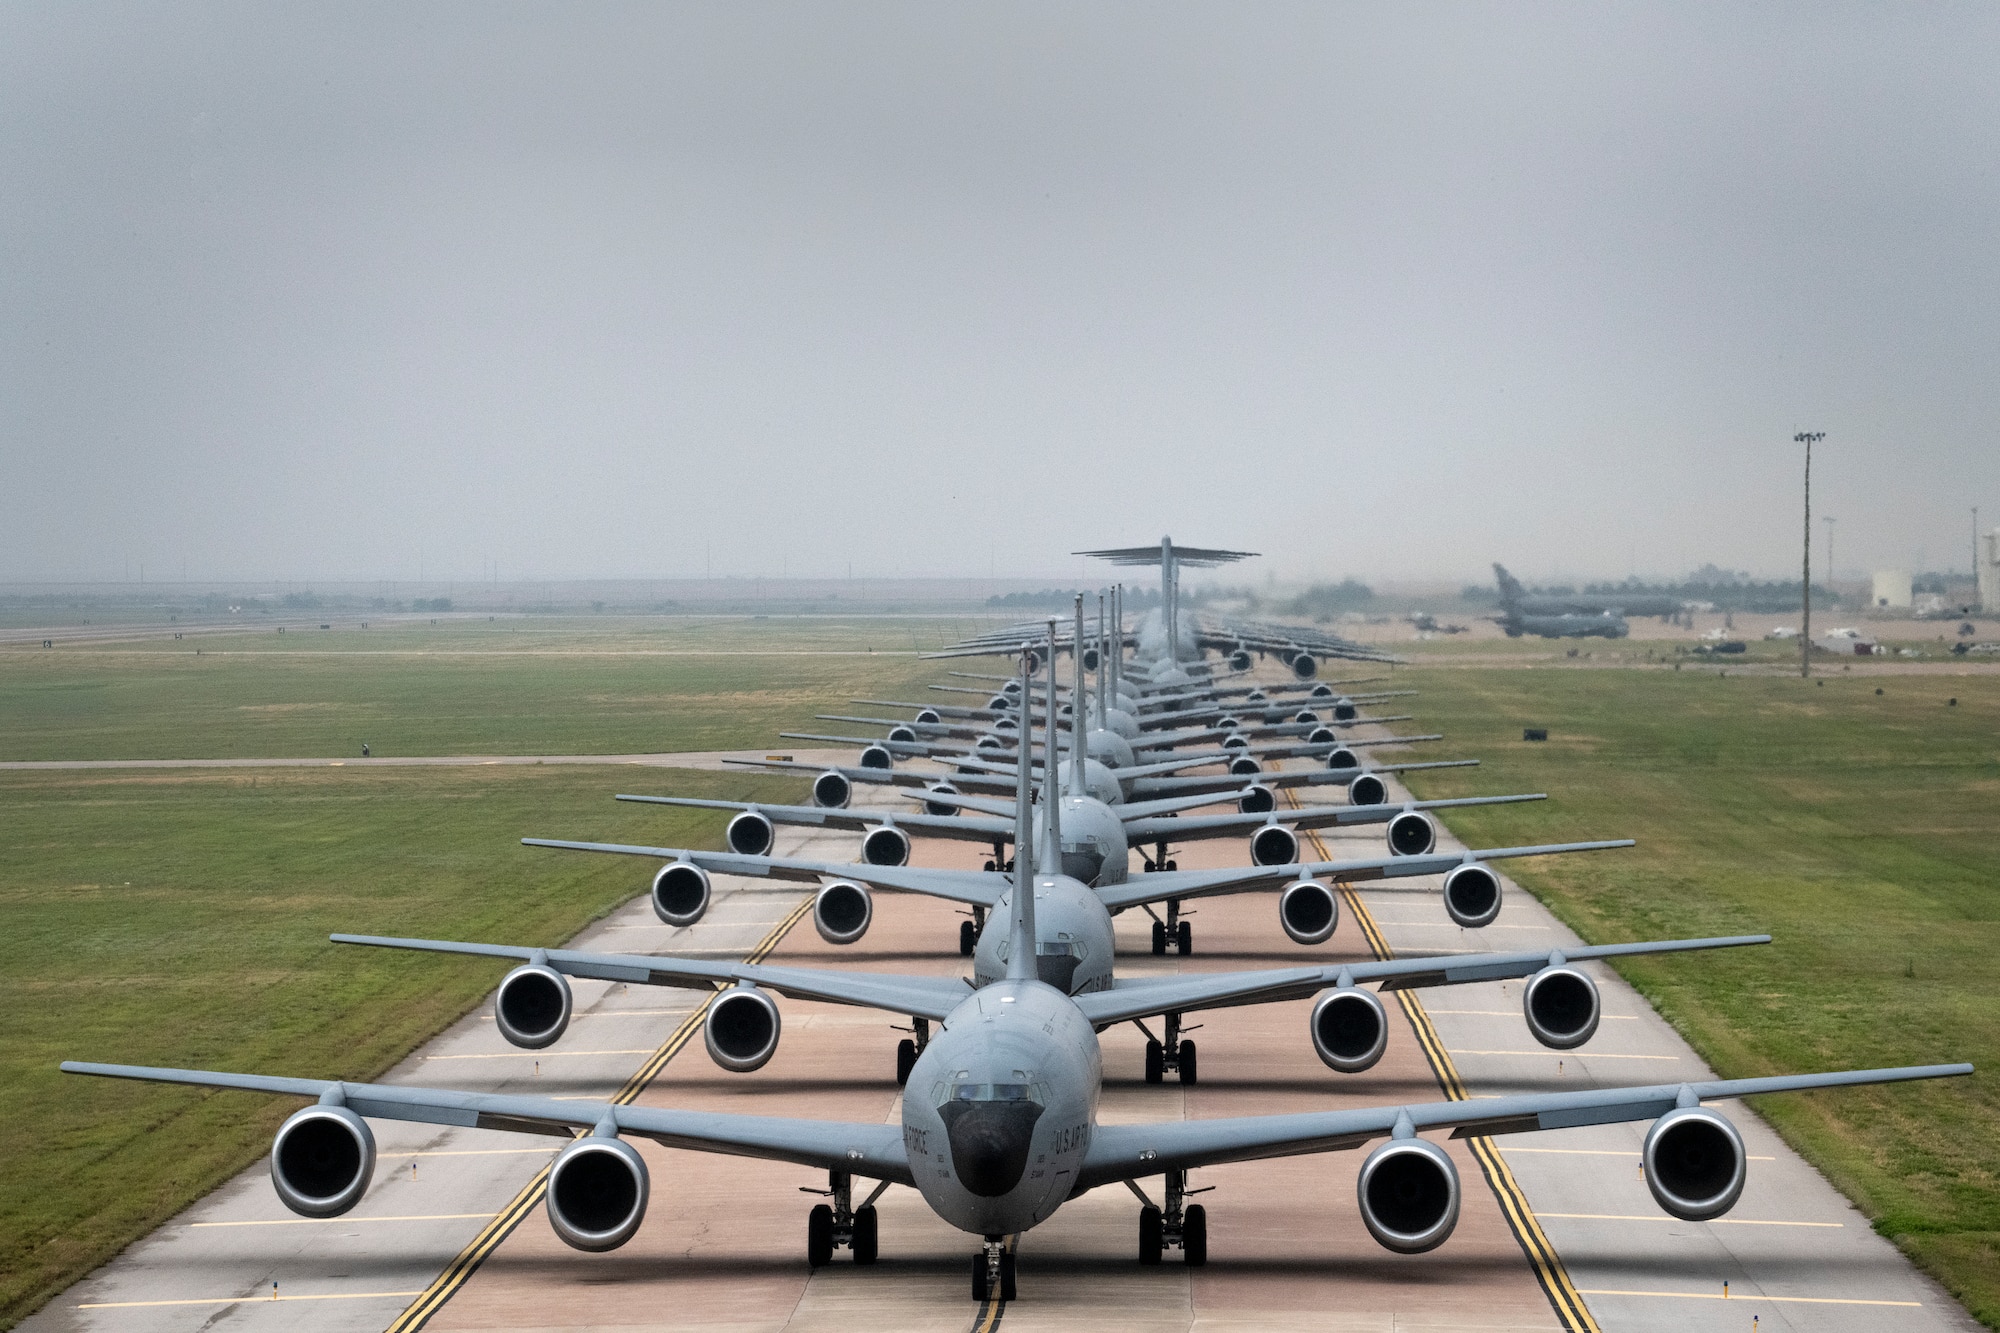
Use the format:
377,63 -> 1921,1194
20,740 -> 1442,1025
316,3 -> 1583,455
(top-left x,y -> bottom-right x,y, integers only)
1398,669 -> 2000,1327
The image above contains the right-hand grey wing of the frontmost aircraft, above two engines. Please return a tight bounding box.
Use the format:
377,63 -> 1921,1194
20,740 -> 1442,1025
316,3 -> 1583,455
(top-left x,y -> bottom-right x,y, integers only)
1076,1065 -> 1972,1191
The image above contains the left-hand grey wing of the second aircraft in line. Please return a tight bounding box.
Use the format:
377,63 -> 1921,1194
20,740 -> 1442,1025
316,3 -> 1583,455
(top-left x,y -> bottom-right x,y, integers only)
328,935 -> 972,1023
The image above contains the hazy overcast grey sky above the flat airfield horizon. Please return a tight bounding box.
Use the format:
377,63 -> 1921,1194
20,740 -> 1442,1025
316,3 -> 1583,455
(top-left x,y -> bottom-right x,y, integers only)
0,0 -> 2000,580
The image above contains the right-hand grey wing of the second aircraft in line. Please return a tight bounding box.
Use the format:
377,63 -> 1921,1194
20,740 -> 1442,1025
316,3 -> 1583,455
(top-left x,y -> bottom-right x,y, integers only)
1076,935 -> 1770,1027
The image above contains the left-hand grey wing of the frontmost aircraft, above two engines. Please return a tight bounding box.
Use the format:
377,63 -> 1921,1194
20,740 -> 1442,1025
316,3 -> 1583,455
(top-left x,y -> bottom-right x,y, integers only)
62,1061 -> 914,1185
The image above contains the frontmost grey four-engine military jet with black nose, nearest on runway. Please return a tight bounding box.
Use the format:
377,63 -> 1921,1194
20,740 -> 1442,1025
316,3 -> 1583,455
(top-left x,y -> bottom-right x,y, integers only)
62,696 -> 1972,1301
